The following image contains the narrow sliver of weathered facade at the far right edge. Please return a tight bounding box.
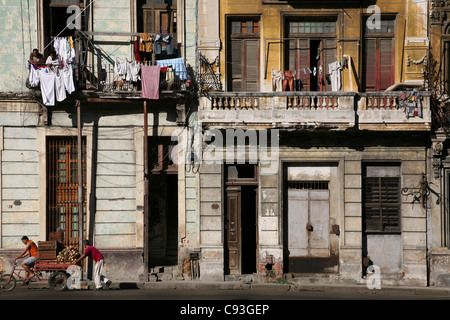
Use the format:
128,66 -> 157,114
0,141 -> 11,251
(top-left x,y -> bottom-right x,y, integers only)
427,1 -> 450,286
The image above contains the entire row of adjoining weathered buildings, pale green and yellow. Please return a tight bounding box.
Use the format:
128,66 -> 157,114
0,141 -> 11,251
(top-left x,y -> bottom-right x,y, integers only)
0,0 -> 450,286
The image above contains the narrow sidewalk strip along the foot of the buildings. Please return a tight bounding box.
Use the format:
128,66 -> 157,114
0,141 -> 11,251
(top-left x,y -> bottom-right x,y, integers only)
29,280 -> 450,297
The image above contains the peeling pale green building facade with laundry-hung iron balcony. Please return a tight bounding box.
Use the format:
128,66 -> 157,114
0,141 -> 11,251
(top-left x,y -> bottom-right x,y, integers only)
0,0 -> 198,281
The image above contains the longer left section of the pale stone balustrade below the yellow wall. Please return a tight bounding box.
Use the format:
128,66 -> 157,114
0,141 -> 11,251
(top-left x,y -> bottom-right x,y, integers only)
199,92 -> 355,129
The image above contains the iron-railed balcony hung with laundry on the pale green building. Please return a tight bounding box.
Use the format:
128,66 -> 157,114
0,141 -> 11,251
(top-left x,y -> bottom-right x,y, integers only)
27,31 -> 194,102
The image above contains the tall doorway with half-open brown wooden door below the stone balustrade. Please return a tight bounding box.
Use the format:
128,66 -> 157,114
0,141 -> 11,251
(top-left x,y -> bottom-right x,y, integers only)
224,165 -> 258,275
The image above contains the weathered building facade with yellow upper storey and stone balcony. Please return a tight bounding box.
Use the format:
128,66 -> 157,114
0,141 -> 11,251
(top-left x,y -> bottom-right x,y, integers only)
194,0 -> 442,286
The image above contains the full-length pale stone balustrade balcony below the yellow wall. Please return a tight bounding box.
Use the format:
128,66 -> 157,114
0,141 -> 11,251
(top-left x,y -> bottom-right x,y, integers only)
199,92 -> 431,131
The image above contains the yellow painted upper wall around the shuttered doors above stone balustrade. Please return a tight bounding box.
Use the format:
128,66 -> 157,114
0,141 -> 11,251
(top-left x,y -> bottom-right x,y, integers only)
220,0 -> 428,91
